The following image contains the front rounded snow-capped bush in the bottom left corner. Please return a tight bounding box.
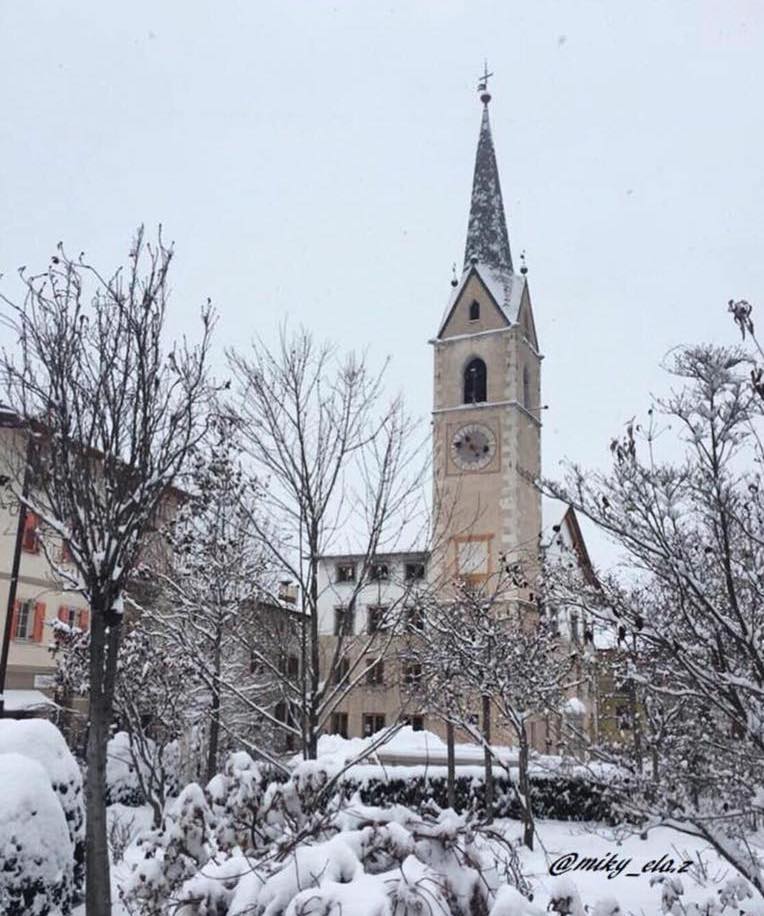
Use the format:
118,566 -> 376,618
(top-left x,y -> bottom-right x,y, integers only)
0,752 -> 75,916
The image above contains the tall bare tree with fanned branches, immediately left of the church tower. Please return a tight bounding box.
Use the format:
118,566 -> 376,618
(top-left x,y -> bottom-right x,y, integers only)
229,331 -> 424,757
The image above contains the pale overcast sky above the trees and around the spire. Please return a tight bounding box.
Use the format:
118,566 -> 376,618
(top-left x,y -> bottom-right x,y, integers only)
0,0 -> 764,568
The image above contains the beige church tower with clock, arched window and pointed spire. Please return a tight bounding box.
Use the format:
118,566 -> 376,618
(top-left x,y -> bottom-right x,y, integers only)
431,81 -> 542,598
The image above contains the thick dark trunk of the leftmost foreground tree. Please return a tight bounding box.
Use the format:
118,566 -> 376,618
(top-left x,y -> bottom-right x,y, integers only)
85,599 -> 119,916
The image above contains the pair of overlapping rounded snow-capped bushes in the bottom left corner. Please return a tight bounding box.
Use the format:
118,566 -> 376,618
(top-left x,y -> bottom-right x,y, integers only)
0,719 -> 85,916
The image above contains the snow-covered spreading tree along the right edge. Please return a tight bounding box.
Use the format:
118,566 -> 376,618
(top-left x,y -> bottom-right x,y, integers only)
545,340 -> 764,893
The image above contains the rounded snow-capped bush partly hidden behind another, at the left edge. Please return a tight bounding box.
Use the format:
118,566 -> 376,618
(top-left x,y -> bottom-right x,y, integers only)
0,719 -> 85,895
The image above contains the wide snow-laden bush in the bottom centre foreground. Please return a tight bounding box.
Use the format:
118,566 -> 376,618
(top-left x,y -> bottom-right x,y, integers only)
124,753 -> 530,916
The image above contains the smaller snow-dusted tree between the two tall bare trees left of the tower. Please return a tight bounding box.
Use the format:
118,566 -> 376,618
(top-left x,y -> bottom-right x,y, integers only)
149,413 -> 273,780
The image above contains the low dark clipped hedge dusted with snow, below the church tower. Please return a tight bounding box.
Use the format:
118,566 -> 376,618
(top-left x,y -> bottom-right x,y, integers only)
341,770 -> 616,823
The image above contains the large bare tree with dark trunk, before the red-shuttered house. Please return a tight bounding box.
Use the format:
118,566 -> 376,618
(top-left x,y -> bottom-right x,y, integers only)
1,229 -> 213,916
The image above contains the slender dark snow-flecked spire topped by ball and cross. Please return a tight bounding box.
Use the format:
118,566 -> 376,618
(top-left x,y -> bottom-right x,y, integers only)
464,81 -> 512,273
